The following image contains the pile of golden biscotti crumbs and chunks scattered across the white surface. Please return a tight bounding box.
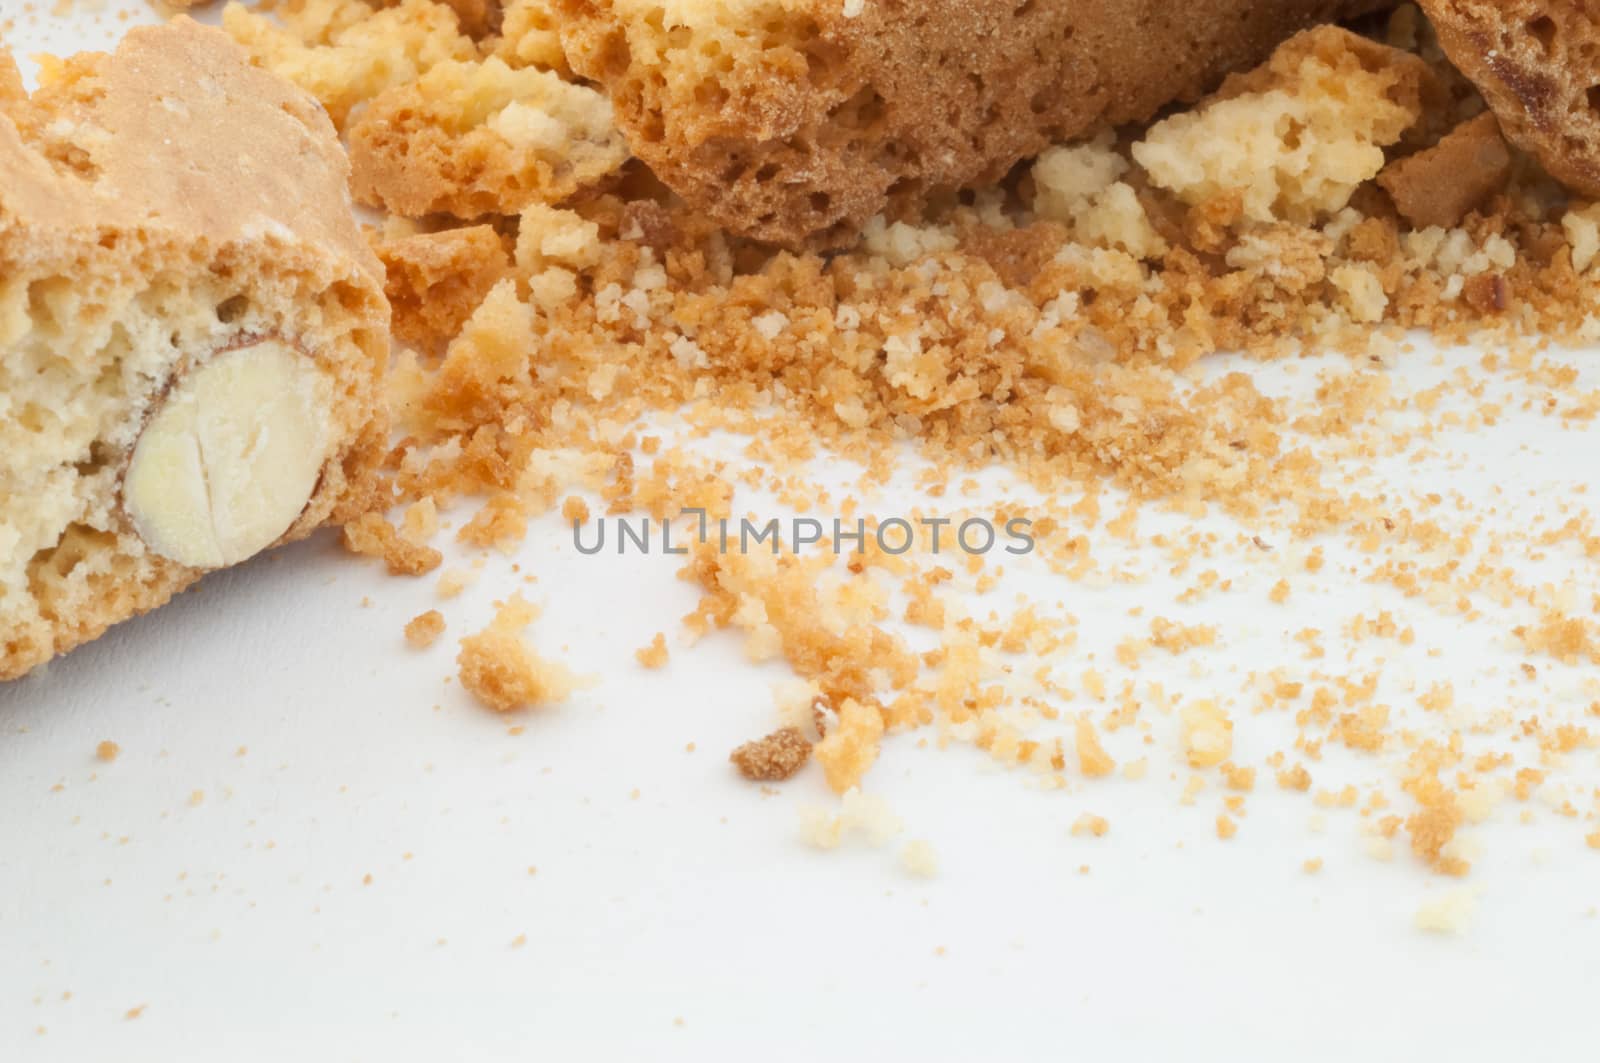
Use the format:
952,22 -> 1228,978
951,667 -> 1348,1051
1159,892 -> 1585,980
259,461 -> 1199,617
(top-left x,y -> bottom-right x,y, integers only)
206,0 -> 1600,890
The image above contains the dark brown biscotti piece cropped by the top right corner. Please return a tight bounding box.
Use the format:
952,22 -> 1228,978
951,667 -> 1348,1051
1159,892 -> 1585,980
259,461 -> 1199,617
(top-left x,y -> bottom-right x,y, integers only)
1422,0 -> 1600,195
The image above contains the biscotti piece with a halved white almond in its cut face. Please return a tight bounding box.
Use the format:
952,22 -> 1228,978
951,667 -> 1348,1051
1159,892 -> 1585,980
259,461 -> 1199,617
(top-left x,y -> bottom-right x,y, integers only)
0,19 -> 389,679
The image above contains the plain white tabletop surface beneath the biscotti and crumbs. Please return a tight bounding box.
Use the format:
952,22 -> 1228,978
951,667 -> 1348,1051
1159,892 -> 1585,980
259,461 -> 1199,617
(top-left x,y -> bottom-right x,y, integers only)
0,5 -> 1600,1060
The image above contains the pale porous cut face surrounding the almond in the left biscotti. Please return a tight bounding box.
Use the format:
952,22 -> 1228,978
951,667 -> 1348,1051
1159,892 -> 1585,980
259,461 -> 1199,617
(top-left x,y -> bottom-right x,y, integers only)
0,240 -> 333,675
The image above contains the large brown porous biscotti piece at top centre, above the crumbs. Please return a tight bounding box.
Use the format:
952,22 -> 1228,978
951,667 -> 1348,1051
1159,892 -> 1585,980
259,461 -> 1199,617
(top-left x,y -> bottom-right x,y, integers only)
554,0 -> 1390,245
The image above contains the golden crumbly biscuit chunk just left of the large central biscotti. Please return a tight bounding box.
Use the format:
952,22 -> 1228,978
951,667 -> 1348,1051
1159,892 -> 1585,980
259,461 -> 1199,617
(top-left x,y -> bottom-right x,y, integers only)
350,56 -> 629,218
